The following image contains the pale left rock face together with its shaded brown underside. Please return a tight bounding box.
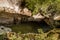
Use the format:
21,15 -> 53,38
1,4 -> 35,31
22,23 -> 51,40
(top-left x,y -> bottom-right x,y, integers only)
0,0 -> 32,24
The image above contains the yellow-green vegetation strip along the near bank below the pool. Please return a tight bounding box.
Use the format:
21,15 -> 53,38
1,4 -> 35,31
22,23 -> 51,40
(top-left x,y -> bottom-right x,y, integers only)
2,29 -> 60,40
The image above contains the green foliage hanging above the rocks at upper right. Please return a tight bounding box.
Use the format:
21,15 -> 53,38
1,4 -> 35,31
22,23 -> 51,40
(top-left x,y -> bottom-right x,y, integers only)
25,0 -> 60,14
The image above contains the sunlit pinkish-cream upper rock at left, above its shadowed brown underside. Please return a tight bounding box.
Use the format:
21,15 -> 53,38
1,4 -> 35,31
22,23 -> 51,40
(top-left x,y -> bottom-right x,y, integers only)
0,0 -> 31,16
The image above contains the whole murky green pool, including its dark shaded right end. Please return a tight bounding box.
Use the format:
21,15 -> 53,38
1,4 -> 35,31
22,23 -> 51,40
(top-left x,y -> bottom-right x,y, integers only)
6,21 -> 51,33
